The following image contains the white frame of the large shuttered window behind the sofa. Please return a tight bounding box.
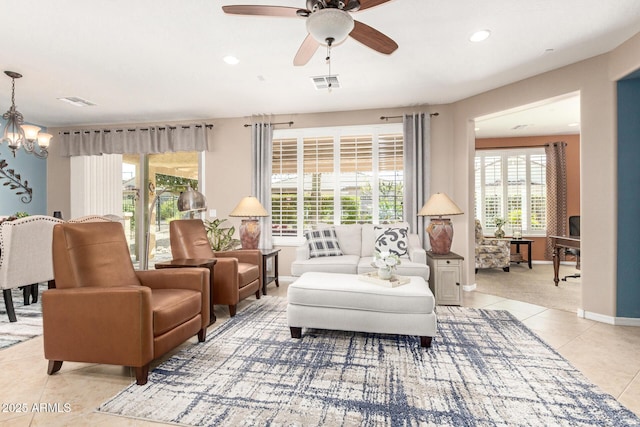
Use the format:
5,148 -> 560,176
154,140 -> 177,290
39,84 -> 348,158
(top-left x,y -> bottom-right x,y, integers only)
270,123 -> 404,246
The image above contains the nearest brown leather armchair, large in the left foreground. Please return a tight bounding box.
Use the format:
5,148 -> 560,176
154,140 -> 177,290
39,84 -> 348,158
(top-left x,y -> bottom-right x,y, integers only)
42,222 -> 210,385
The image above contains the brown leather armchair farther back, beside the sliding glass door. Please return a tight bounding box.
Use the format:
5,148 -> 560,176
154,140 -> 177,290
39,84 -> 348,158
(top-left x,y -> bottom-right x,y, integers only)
169,219 -> 263,317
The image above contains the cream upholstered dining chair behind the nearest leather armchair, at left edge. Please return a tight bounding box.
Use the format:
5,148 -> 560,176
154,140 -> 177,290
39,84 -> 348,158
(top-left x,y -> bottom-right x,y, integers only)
0,215 -> 62,322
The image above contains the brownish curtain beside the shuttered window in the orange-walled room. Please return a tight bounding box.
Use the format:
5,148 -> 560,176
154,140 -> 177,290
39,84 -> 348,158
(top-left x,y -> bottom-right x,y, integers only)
544,142 -> 568,259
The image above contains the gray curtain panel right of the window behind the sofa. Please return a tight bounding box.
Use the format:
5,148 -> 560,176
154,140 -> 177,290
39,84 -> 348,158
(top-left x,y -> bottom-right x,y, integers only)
402,113 -> 431,248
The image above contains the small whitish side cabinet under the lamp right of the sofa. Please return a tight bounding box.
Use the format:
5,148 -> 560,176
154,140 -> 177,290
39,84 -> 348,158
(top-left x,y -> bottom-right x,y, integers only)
427,251 -> 464,305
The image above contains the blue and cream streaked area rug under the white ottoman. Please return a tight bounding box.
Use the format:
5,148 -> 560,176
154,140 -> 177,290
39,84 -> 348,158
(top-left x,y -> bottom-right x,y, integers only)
98,297 -> 640,426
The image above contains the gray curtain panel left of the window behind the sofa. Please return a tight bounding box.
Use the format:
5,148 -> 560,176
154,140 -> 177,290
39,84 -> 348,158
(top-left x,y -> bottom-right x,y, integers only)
251,122 -> 273,249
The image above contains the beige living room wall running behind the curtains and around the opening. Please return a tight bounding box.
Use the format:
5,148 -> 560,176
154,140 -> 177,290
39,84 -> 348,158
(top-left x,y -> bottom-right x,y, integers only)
47,30 -> 640,316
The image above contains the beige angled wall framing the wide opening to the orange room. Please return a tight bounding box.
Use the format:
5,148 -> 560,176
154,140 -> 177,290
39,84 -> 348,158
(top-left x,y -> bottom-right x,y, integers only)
453,35 -> 640,317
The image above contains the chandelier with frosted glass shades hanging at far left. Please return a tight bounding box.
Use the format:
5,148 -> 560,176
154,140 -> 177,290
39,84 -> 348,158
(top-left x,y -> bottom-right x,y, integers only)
2,71 -> 53,159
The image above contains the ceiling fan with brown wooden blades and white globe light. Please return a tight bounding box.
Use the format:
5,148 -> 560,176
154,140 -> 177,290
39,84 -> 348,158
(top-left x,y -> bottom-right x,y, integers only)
222,0 -> 398,66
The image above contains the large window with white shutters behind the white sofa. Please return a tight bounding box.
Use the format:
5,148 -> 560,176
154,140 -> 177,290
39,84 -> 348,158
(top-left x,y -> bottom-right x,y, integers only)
271,124 -> 404,239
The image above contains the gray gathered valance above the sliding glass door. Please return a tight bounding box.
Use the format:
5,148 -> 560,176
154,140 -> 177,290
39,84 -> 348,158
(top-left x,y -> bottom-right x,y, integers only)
60,124 -> 211,157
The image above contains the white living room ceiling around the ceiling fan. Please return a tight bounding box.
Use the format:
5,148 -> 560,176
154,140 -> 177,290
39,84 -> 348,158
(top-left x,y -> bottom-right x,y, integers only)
0,0 -> 640,136
